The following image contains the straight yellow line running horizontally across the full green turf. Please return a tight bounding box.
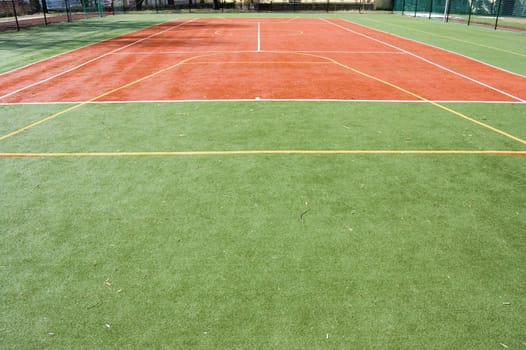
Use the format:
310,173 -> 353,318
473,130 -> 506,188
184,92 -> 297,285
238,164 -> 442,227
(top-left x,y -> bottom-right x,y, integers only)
0,150 -> 526,158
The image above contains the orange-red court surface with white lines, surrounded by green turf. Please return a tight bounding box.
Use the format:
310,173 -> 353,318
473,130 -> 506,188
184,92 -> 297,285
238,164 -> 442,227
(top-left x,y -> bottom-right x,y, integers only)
0,18 -> 526,103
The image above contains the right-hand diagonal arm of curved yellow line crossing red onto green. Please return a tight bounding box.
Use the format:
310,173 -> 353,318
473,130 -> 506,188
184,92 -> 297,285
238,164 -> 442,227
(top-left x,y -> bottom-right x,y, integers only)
298,53 -> 526,145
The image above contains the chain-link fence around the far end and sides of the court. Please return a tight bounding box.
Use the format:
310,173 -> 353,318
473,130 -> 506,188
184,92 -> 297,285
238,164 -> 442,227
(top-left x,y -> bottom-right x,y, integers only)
0,0 -> 526,31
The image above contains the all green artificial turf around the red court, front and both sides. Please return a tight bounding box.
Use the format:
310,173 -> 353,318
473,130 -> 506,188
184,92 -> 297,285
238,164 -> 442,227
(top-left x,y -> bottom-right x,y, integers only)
0,14 -> 526,349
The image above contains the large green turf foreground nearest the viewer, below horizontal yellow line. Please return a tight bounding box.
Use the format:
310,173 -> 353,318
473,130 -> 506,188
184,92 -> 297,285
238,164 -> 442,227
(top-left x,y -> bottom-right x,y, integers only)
0,155 -> 526,349
